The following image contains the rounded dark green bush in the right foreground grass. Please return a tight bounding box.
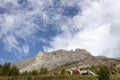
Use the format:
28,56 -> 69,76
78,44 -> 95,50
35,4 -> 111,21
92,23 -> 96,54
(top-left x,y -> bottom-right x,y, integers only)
98,66 -> 110,80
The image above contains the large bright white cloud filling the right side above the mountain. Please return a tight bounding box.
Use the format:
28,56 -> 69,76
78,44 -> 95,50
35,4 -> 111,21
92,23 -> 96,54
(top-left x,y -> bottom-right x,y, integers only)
45,0 -> 120,57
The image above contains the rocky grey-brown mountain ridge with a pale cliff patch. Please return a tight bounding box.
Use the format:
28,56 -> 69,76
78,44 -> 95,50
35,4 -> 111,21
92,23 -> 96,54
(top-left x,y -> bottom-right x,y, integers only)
15,49 -> 120,72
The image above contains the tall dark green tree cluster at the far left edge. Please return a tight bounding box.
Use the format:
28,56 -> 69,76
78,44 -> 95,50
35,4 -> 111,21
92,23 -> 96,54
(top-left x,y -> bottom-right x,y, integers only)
0,63 -> 19,76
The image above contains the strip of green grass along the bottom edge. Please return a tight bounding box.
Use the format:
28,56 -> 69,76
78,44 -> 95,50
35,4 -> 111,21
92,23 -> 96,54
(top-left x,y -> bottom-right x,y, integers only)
0,75 -> 120,80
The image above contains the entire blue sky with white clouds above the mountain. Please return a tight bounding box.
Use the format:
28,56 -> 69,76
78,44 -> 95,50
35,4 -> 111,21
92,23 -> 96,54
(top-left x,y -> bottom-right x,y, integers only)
0,0 -> 120,64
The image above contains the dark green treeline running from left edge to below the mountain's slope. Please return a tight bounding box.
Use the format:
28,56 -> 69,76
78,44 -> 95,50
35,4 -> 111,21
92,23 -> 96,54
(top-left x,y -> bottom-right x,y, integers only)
0,63 -> 49,76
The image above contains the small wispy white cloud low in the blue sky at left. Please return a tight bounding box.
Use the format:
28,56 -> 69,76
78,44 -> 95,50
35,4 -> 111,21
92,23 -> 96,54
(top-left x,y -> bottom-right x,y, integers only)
2,35 -> 29,55
